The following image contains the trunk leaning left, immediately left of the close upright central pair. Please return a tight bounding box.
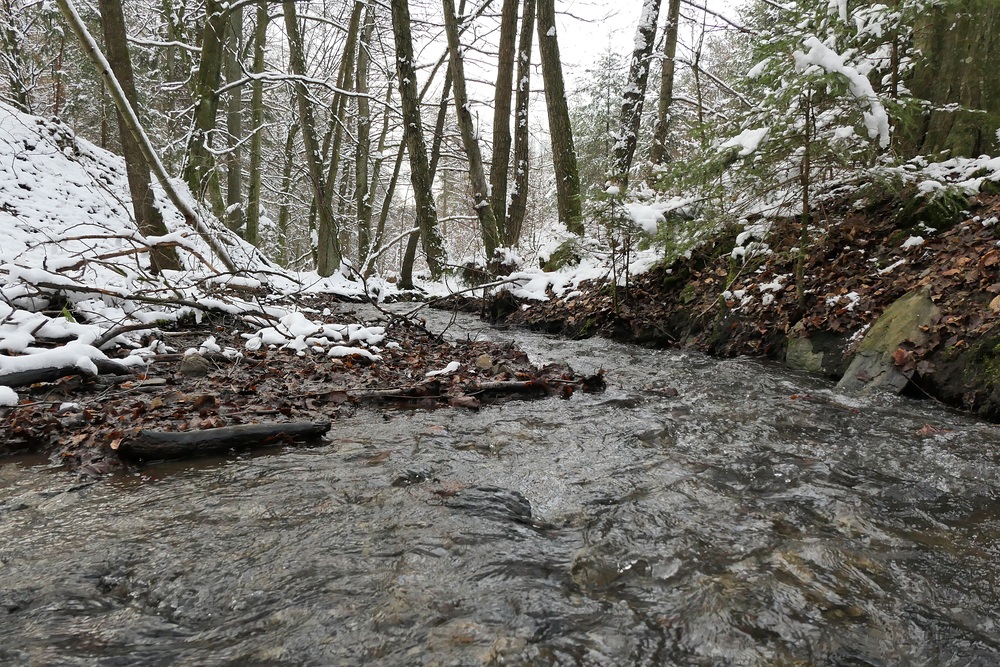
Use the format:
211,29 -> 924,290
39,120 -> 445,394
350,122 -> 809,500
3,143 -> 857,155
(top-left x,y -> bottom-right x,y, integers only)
442,0 -> 500,265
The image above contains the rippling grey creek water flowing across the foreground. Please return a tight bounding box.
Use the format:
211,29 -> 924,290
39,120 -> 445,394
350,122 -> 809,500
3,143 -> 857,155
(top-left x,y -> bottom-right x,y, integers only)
0,314 -> 1000,666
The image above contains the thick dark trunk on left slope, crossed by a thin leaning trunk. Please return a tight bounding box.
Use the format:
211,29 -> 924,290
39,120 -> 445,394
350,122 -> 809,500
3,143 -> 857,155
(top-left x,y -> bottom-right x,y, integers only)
99,0 -> 181,273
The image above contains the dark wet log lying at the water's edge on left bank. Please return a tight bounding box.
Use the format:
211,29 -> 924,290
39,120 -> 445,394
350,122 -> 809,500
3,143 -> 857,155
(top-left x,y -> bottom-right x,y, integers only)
117,422 -> 330,461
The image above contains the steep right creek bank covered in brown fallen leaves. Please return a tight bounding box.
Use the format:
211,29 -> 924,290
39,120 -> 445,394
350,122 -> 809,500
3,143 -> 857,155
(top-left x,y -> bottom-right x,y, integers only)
481,194 -> 1000,422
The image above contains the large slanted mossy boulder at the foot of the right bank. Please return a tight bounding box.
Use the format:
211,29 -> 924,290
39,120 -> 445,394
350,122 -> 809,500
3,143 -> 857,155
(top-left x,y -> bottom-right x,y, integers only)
837,290 -> 940,394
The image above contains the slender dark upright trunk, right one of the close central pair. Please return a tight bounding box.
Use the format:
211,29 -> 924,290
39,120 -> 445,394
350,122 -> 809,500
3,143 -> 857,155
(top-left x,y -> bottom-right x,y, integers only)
504,0 -> 535,247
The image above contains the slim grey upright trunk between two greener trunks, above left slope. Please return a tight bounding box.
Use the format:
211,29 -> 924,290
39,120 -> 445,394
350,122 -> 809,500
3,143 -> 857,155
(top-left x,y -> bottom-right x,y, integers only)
225,3 -> 246,235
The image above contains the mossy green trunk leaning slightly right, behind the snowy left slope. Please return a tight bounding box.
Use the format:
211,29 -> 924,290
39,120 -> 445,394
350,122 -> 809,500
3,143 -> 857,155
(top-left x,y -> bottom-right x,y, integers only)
184,0 -> 227,206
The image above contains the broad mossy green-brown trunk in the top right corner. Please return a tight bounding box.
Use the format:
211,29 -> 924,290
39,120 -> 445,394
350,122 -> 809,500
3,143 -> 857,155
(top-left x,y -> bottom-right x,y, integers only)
899,0 -> 1000,157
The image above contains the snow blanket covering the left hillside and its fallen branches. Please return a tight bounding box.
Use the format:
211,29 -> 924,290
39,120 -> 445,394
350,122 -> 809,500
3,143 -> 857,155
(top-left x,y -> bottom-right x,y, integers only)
0,103 -> 404,378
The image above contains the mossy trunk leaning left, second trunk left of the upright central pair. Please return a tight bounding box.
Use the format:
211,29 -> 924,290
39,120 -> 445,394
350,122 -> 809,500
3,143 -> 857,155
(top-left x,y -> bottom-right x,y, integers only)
391,0 -> 444,279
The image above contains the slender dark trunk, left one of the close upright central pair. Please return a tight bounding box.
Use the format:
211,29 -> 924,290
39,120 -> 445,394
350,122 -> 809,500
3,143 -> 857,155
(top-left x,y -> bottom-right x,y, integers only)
490,0 -> 520,245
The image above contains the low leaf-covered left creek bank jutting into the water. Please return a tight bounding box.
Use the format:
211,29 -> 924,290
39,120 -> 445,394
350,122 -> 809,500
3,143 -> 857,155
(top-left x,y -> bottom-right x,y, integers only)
0,303 -> 604,477
